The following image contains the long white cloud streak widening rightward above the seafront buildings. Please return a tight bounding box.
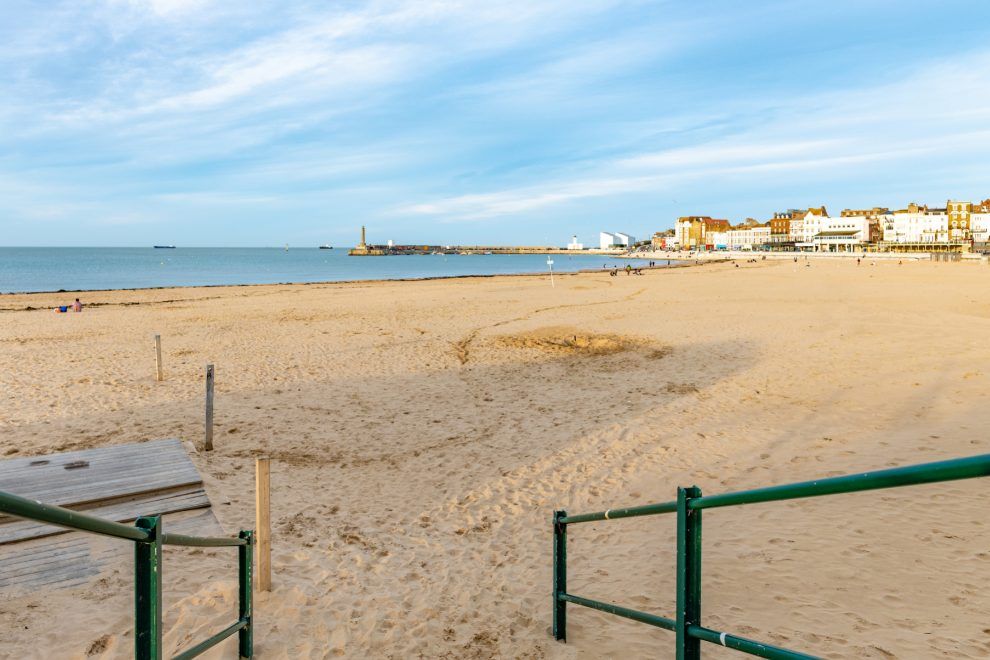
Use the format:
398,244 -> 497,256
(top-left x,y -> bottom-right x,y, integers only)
393,47 -> 990,221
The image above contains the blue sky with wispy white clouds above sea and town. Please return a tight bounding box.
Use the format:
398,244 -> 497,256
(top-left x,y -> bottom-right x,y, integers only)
0,0 -> 990,247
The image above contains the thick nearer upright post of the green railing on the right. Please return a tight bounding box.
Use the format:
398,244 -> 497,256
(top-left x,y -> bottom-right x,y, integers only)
674,486 -> 701,660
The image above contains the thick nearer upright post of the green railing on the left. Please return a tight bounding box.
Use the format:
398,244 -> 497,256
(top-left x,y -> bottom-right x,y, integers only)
134,516 -> 162,660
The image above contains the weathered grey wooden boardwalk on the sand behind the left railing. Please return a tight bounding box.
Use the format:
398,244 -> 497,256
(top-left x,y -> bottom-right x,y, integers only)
0,439 -> 223,593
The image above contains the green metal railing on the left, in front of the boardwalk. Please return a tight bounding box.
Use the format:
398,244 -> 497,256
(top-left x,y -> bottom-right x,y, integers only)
0,491 -> 254,660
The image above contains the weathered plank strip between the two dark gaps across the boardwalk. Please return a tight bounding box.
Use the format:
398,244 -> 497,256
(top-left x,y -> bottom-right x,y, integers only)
0,486 -> 210,544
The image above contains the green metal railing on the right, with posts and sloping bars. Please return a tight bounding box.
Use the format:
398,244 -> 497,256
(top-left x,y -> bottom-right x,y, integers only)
553,454 -> 990,660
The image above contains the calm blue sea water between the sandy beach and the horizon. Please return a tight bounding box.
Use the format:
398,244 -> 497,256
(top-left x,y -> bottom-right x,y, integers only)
0,247 -> 666,293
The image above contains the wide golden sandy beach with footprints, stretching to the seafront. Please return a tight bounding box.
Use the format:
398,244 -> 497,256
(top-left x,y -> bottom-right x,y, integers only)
0,261 -> 990,658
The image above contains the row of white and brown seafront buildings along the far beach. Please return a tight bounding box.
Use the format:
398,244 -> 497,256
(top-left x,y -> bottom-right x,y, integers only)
653,199 -> 990,252
